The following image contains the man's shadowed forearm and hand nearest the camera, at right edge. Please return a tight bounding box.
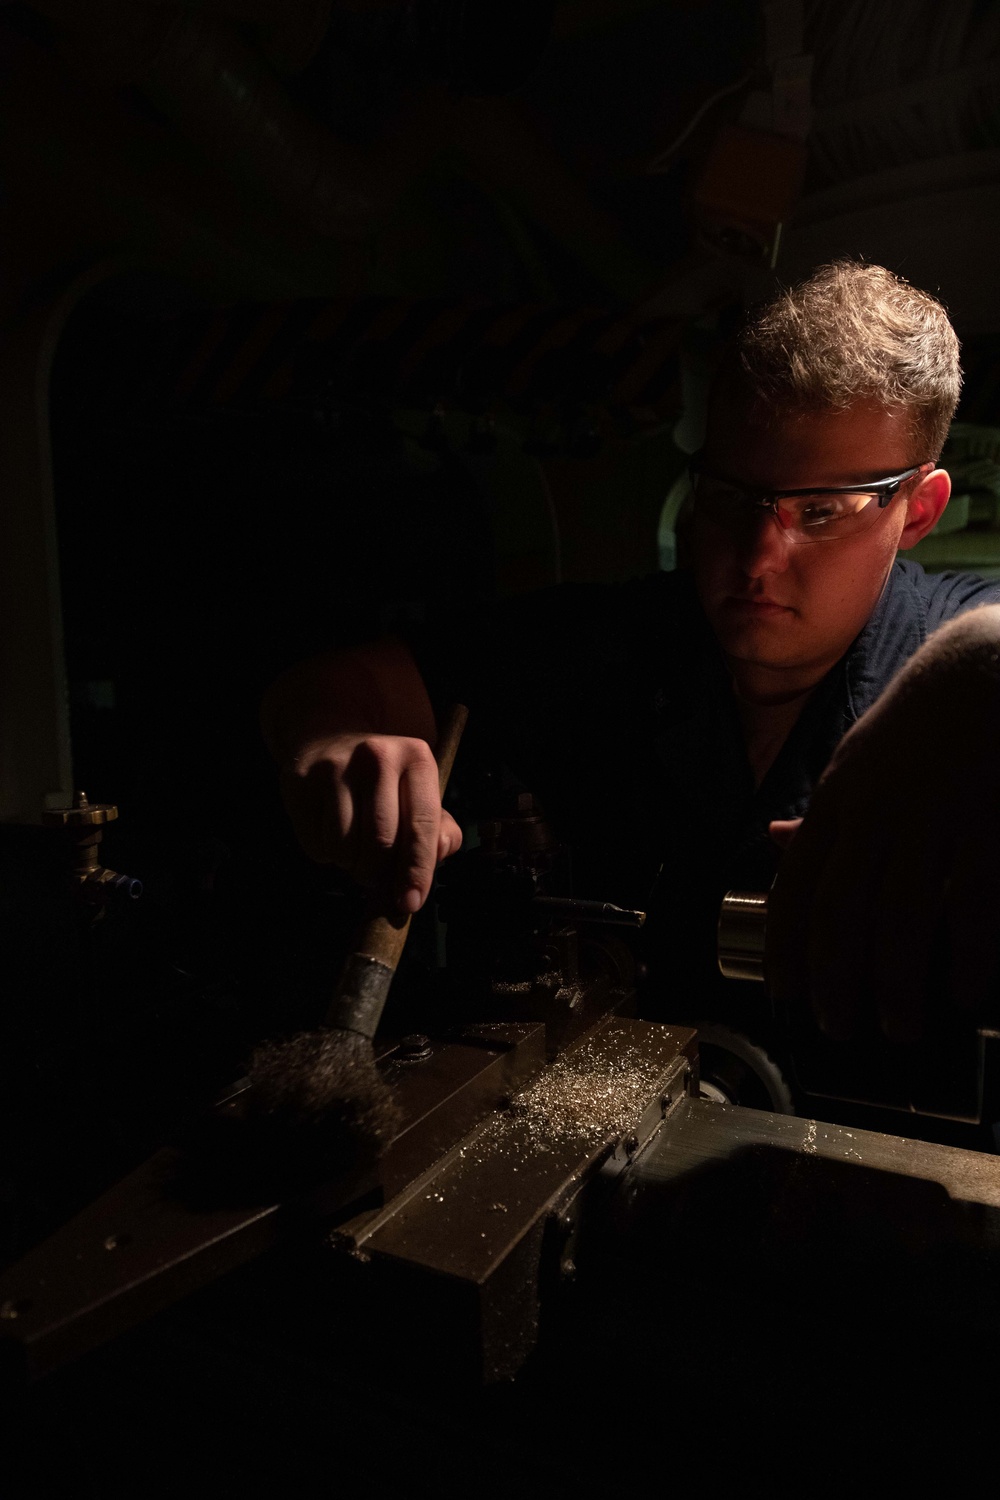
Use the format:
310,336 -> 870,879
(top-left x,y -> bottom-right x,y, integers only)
768,606 -> 1000,1043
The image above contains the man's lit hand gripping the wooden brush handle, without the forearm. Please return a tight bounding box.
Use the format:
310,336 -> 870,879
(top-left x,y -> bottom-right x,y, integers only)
280,734 -> 462,912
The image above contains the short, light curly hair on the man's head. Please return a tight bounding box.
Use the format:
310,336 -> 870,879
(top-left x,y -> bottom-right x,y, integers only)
726,260 -> 961,461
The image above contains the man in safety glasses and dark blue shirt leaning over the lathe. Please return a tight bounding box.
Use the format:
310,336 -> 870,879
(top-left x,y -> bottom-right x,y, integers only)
264,261 -> 1000,1037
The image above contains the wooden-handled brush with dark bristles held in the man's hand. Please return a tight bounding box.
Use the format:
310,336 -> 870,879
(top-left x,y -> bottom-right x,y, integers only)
244,704 -> 468,1181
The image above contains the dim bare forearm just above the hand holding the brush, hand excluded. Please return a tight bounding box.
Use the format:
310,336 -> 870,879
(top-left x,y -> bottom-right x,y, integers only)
261,638 -> 436,767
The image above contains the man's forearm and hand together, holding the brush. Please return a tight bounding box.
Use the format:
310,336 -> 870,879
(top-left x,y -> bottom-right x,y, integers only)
261,639 -> 462,912
